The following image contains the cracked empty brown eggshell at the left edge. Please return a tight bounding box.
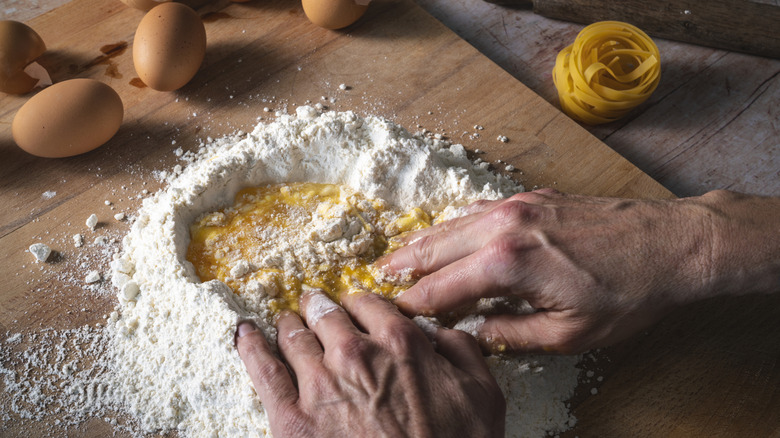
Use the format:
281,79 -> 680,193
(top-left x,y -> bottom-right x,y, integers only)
0,20 -> 51,94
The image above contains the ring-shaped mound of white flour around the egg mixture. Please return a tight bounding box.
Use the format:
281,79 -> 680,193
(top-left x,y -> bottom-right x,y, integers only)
106,107 -> 578,437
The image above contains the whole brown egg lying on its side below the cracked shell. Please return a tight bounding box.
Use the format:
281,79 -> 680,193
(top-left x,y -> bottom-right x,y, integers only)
11,79 -> 124,158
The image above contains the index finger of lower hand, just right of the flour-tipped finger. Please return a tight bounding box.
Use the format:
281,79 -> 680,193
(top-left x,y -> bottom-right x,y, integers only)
341,291 -> 423,339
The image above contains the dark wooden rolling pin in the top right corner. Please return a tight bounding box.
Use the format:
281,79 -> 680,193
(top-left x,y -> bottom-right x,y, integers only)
485,0 -> 780,58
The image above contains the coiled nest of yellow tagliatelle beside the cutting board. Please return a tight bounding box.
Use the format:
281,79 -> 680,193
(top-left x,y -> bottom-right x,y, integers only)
553,21 -> 661,125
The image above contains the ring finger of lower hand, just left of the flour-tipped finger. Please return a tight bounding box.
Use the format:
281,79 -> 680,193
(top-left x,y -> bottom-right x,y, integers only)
276,311 -> 323,380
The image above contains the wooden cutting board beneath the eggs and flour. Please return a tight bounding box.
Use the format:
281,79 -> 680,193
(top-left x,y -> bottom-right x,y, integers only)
0,0 -> 780,436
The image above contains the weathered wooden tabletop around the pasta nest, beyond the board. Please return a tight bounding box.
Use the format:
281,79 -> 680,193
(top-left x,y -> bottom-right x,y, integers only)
417,0 -> 780,196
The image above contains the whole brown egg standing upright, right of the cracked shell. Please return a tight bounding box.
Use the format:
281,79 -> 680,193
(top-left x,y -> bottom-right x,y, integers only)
133,2 -> 206,91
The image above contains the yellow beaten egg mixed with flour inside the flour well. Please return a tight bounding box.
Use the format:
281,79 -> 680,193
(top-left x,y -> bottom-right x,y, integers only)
187,183 -> 433,313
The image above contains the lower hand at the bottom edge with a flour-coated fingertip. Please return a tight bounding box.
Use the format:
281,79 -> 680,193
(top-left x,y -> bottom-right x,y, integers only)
236,292 -> 505,438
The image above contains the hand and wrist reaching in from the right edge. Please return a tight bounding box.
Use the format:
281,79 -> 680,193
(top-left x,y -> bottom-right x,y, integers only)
378,190 -> 780,353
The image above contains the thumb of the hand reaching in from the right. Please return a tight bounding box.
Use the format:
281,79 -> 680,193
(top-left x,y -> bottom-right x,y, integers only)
477,311 -> 588,354
